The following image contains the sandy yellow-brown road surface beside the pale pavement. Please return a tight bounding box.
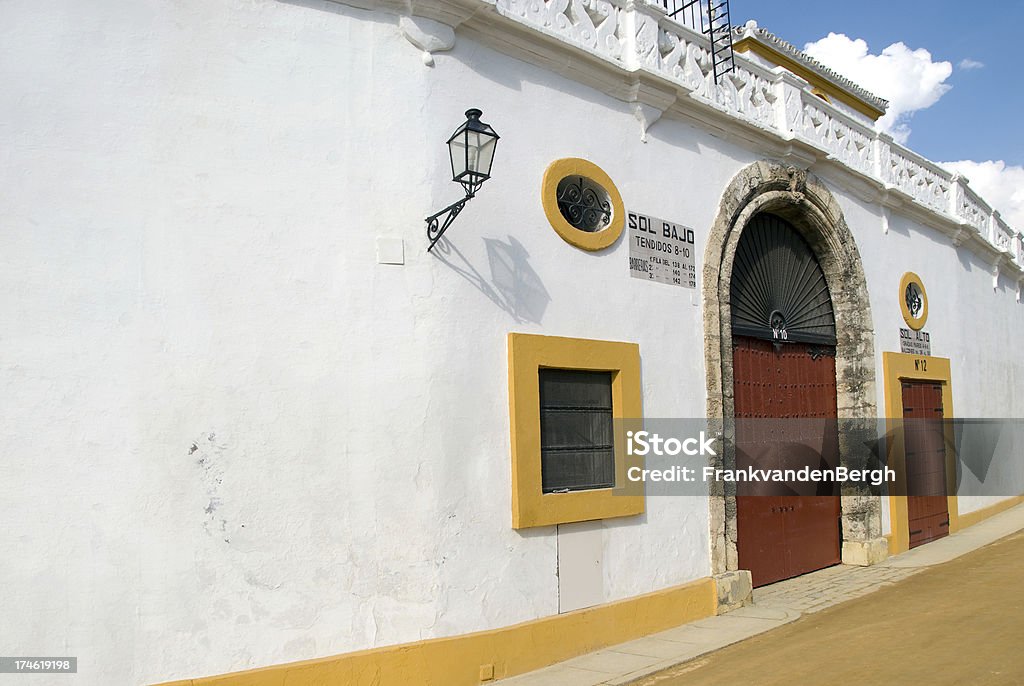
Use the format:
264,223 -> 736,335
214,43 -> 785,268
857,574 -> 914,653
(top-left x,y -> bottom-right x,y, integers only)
638,532 -> 1024,686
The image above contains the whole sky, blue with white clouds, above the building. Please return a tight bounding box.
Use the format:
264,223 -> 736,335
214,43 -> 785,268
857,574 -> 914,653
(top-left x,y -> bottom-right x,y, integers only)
745,0 -> 1024,231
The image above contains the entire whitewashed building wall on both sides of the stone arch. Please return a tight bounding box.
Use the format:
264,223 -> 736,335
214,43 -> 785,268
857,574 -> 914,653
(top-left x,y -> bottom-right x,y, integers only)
0,0 -> 1021,684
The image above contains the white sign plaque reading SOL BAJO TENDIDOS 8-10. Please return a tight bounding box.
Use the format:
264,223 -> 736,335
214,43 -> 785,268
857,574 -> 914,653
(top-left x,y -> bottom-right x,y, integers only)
627,212 -> 697,289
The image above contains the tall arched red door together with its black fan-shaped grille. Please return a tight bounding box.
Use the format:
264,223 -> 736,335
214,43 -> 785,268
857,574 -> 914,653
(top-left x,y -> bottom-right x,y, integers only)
728,212 -> 841,587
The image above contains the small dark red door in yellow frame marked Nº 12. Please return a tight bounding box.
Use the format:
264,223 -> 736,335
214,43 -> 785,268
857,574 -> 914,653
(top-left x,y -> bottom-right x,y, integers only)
902,381 -> 949,548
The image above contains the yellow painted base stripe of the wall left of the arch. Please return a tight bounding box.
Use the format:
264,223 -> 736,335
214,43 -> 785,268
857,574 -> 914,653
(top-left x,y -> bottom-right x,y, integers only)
151,578 -> 717,686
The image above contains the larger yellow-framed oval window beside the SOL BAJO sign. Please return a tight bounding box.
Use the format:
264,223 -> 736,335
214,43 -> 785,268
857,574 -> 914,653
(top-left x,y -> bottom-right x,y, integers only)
541,158 -> 626,251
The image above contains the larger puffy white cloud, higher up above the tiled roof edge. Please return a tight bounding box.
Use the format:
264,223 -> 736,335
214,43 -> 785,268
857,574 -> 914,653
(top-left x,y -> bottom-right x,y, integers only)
804,33 -> 953,142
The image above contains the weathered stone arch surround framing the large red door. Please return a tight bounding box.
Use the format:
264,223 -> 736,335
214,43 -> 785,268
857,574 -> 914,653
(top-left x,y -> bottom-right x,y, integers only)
702,162 -> 888,574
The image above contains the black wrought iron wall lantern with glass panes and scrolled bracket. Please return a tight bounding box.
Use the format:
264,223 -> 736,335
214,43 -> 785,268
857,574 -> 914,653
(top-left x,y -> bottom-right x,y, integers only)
426,109 -> 500,252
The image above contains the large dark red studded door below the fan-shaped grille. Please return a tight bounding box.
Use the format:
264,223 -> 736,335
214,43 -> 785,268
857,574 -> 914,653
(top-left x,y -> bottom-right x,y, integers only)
733,336 -> 841,587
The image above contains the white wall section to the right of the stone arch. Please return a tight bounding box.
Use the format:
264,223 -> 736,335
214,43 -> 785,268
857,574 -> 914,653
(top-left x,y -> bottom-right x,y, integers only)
819,182 -> 1024,522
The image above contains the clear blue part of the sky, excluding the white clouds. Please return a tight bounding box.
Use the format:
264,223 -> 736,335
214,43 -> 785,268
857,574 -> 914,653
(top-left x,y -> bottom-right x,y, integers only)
745,0 -> 1024,165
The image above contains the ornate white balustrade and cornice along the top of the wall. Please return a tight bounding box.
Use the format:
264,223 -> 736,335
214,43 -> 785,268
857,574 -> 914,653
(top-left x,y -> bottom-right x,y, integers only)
334,0 -> 1024,280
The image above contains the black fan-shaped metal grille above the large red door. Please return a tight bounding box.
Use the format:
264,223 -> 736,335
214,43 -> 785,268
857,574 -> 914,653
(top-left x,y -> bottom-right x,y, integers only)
729,214 -> 836,345
